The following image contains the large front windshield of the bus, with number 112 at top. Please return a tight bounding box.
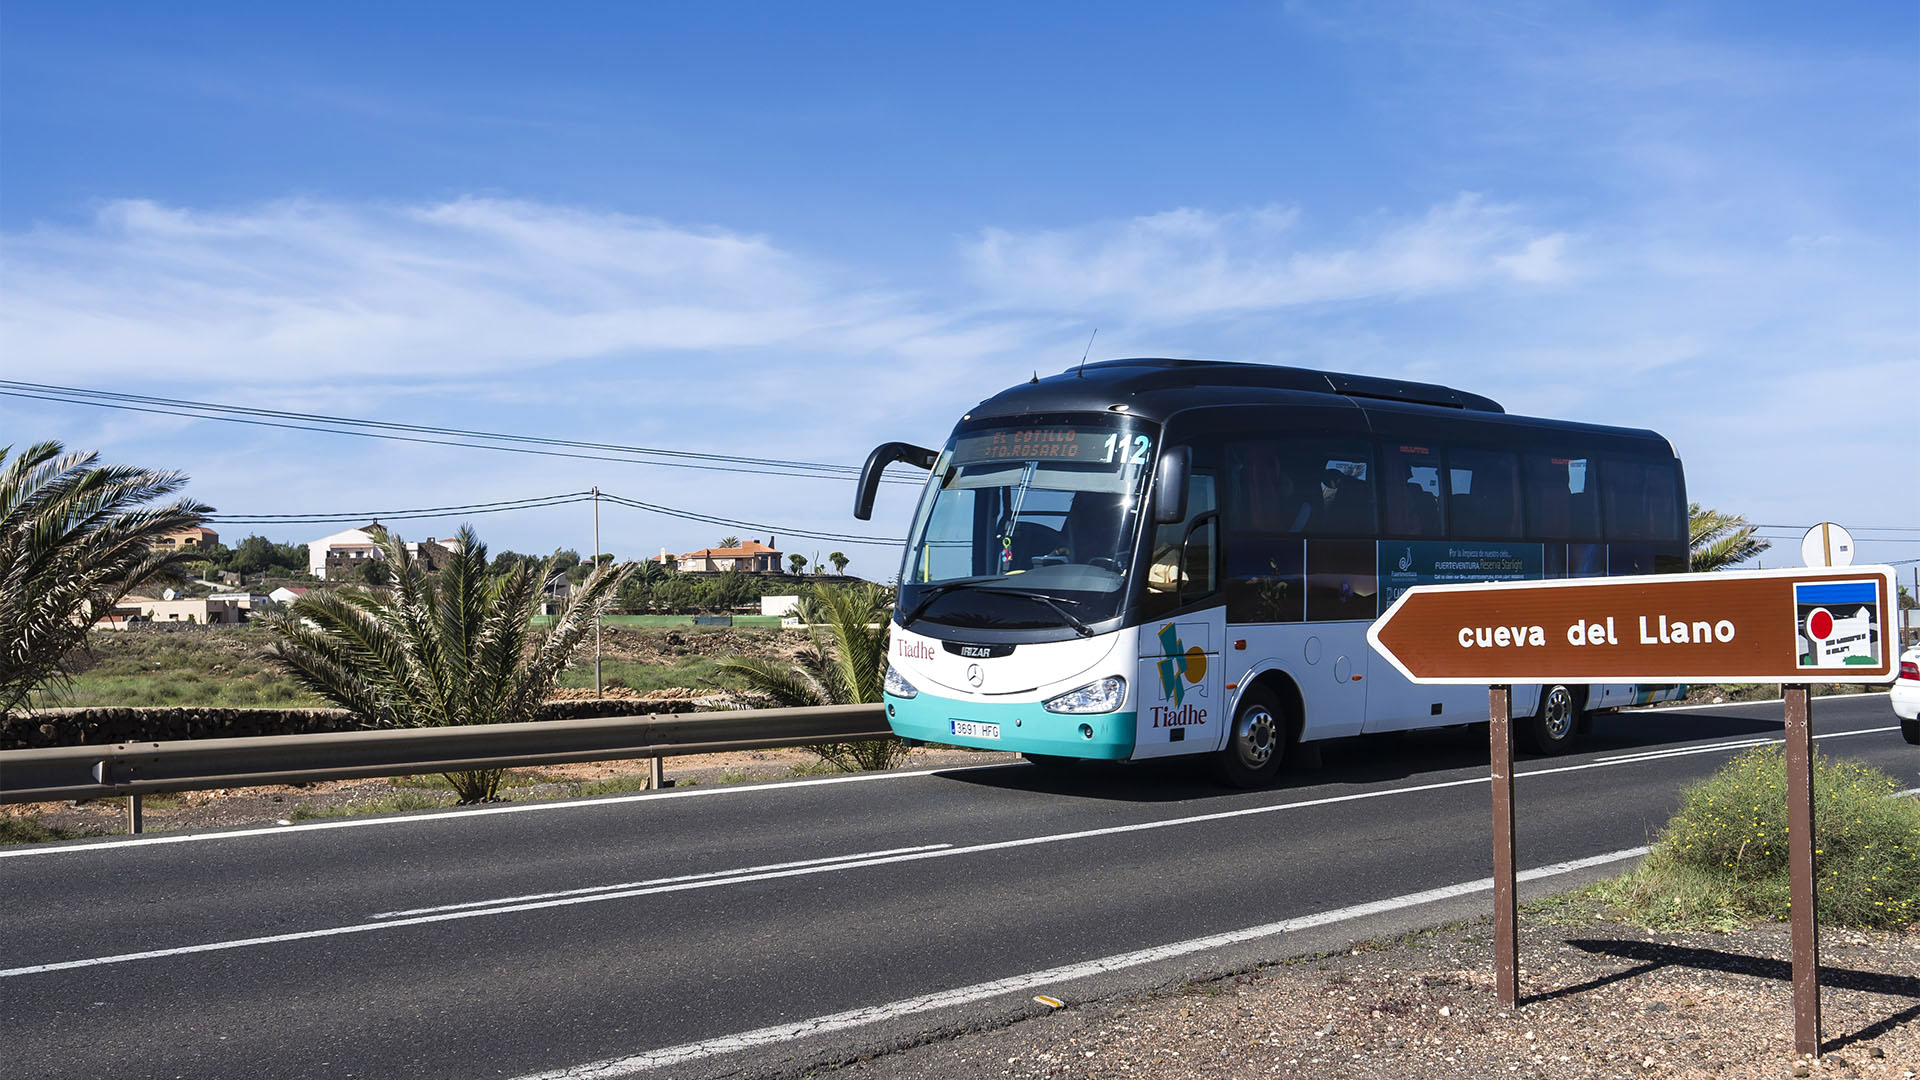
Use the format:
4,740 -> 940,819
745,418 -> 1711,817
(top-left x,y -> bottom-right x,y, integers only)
897,413 -> 1158,632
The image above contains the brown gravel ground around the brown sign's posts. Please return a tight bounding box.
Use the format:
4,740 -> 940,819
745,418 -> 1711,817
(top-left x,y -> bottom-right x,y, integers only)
816,919 -> 1920,1080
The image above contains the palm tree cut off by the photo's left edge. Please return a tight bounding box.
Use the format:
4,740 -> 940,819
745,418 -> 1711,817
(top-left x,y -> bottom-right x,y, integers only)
0,442 -> 213,717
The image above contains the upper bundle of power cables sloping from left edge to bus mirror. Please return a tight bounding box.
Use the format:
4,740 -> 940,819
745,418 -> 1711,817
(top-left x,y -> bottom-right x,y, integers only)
0,379 -> 918,484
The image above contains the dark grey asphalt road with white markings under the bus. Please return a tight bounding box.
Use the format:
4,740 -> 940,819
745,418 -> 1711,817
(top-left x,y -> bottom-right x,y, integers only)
0,694 -> 1920,1078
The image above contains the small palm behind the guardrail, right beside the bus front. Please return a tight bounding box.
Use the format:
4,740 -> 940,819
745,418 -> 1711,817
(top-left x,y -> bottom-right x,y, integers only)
718,584 -> 906,773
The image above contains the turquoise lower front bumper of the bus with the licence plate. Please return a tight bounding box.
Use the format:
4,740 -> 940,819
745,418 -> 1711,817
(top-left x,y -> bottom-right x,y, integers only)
885,690 -> 1139,761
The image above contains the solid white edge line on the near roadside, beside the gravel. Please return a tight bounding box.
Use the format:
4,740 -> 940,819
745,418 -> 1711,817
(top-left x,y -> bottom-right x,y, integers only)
503,847 -> 1647,1080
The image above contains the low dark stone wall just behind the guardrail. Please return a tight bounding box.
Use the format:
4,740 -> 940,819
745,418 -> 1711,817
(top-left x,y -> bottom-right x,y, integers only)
0,698 -> 710,749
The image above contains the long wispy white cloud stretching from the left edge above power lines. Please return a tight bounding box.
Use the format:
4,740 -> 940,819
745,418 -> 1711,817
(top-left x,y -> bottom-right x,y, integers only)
0,198 -> 972,380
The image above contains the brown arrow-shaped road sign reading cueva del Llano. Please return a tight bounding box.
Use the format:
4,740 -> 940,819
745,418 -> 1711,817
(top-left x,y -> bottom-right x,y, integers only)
1367,567 -> 1899,684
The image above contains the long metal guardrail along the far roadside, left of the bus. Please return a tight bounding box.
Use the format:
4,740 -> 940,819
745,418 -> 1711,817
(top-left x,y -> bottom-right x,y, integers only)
0,705 -> 893,803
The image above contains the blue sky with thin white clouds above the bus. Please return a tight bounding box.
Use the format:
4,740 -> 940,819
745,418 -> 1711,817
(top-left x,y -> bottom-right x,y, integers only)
0,0 -> 1920,578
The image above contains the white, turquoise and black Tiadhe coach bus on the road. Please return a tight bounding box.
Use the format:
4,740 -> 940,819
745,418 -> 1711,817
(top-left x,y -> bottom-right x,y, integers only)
854,359 -> 1688,788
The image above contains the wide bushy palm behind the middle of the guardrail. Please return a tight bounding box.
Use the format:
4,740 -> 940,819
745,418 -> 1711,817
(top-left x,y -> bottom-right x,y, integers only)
267,527 -> 634,803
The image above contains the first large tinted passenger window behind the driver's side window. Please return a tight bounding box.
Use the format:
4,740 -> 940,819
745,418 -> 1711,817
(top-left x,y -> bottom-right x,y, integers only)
1223,438 -> 1373,536
